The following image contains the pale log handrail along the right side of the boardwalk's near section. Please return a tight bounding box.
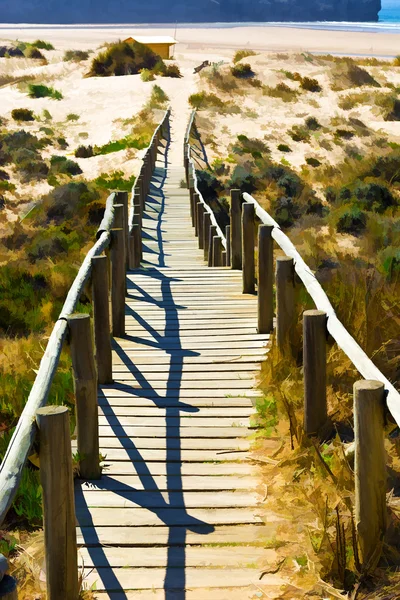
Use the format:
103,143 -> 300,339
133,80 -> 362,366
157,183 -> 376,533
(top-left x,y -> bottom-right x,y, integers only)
243,193 -> 400,425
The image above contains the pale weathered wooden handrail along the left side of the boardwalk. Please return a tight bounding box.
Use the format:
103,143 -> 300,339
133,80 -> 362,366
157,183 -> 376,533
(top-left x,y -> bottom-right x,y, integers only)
0,109 -> 170,523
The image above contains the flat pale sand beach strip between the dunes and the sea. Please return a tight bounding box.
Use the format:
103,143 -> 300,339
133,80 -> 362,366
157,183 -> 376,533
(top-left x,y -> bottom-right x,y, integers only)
0,24 -> 400,58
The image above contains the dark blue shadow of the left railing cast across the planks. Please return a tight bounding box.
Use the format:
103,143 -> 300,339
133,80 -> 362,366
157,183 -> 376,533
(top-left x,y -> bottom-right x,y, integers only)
76,124 -> 214,600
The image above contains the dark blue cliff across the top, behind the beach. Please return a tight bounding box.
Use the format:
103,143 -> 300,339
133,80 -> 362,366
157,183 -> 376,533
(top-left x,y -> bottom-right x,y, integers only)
0,0 -> 381,23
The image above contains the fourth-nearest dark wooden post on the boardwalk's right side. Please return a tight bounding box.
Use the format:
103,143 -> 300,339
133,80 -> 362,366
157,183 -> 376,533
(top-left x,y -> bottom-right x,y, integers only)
257,225 -> 274,333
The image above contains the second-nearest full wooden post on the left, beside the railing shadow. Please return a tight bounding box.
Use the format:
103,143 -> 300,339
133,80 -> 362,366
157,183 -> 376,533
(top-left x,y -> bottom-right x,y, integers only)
68,313 -> 101,479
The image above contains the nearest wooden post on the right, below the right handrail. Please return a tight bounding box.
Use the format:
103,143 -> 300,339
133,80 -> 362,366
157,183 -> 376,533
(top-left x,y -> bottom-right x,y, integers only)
354,381 -> 387,572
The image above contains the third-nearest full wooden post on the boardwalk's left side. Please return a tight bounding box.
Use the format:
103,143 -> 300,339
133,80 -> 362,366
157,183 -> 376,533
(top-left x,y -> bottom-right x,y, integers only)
92,256 -> 113,384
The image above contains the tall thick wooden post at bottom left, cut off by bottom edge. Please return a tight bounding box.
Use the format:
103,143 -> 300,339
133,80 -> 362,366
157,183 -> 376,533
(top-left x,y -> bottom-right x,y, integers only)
36,406 -> 79,600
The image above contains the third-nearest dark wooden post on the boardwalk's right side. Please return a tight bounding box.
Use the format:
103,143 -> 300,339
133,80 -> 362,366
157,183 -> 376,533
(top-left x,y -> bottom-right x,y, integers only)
276,256 -> 295,353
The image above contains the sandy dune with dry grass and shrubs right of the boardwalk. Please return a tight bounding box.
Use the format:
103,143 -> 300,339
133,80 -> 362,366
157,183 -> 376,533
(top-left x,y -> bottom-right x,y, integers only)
193,49 -> 400,599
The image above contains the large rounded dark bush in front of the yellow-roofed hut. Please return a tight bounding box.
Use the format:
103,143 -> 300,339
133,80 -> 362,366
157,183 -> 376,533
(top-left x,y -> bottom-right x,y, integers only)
88,42 -> 161,77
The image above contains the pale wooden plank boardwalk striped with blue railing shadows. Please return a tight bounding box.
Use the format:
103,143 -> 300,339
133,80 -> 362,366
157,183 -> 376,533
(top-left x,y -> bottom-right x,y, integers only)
76,124 -> 281,600
